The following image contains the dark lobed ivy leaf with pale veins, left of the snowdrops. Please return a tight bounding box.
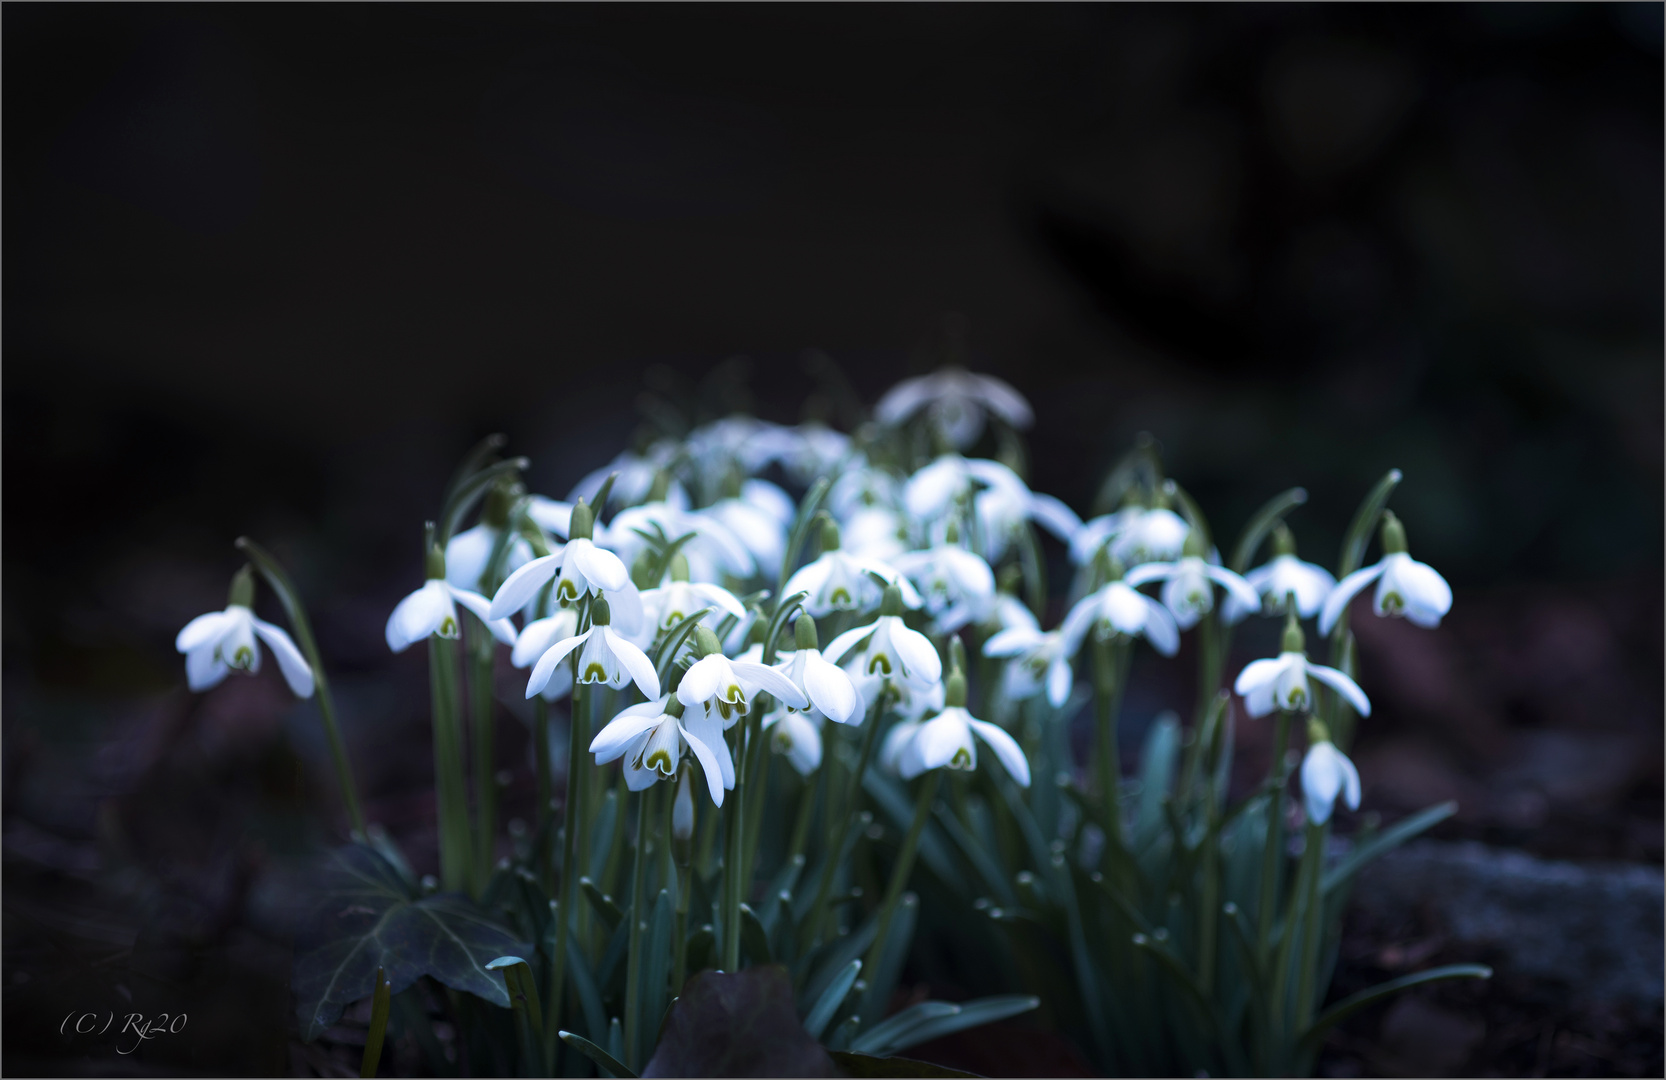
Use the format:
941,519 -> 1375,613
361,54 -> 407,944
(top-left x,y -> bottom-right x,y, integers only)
293,843 -> 526,1042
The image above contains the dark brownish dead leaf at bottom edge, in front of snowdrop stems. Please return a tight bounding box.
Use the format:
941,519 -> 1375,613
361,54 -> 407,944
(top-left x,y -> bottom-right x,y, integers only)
641,963 -> 835,1077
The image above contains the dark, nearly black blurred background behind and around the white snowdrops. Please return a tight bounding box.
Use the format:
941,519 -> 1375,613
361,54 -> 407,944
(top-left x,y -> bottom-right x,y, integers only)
3,3 -> 1666,1075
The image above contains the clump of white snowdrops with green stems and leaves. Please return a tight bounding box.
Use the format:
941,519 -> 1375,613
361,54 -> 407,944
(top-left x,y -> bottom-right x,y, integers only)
178,368 -> 1481,1075
